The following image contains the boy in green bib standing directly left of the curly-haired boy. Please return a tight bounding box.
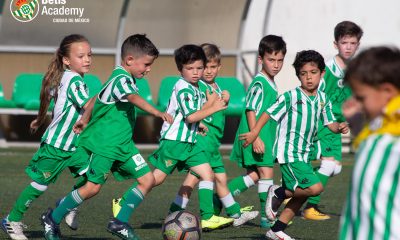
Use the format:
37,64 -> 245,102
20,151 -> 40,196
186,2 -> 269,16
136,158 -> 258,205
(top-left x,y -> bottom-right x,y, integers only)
229,35 -> 286,228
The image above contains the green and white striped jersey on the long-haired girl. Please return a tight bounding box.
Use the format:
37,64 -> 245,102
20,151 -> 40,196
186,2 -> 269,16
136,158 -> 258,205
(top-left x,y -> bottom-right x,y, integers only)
42,70 -> 89,151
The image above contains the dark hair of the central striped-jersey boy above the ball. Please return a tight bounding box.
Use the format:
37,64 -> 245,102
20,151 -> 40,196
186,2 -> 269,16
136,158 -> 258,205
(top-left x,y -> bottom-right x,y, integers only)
174,44 -> 207,71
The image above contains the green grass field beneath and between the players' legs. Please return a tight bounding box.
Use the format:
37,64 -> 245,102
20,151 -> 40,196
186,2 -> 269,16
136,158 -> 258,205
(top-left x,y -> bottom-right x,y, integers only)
0,148 -> 353,240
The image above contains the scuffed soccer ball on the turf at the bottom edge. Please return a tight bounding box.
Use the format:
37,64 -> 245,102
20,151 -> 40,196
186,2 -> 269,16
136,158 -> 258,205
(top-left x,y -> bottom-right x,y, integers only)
162,210 -> 201,240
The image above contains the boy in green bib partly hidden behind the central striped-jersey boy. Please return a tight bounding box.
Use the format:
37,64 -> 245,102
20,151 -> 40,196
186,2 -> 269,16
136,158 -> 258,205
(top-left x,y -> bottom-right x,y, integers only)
166,43 -> 258,227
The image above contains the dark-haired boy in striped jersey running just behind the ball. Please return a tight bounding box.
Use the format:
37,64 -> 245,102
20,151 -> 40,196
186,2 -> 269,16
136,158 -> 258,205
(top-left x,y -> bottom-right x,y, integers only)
150,45 -> 233,230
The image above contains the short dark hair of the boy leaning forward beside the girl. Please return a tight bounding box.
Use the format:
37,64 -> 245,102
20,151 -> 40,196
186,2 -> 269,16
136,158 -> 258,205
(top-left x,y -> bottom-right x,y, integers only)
121,34 -> 159,59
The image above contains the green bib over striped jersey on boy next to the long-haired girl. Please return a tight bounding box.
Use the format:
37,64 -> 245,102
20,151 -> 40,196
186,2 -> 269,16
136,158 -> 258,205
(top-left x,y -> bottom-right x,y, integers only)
79,66 -> 139,161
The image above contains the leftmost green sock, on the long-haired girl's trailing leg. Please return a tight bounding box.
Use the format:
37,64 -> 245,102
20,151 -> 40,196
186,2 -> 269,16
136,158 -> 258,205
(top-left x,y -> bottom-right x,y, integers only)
8,184 -> 47,222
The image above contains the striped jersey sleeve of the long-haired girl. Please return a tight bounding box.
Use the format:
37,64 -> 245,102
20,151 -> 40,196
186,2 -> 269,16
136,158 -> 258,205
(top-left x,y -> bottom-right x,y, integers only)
67,77 -> 89,108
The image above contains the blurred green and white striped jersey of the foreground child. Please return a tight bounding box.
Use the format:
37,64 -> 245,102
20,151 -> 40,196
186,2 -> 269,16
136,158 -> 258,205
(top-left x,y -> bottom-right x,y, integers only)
339,134 -> 400,240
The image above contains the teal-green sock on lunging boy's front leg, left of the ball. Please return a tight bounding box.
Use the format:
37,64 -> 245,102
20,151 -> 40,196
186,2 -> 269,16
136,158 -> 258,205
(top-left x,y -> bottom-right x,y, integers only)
116,184 -> 144,222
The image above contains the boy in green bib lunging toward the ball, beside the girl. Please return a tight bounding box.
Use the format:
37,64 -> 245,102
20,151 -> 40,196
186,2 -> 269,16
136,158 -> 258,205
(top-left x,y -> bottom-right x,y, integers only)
41,34 -> 172,239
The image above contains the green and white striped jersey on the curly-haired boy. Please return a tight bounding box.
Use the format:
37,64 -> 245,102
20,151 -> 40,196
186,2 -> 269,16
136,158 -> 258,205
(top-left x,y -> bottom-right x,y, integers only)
266,87 -> 335,164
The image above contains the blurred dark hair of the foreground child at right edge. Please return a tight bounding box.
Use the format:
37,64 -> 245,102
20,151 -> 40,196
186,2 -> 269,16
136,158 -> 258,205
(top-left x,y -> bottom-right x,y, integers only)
344,46 -> 400,89
